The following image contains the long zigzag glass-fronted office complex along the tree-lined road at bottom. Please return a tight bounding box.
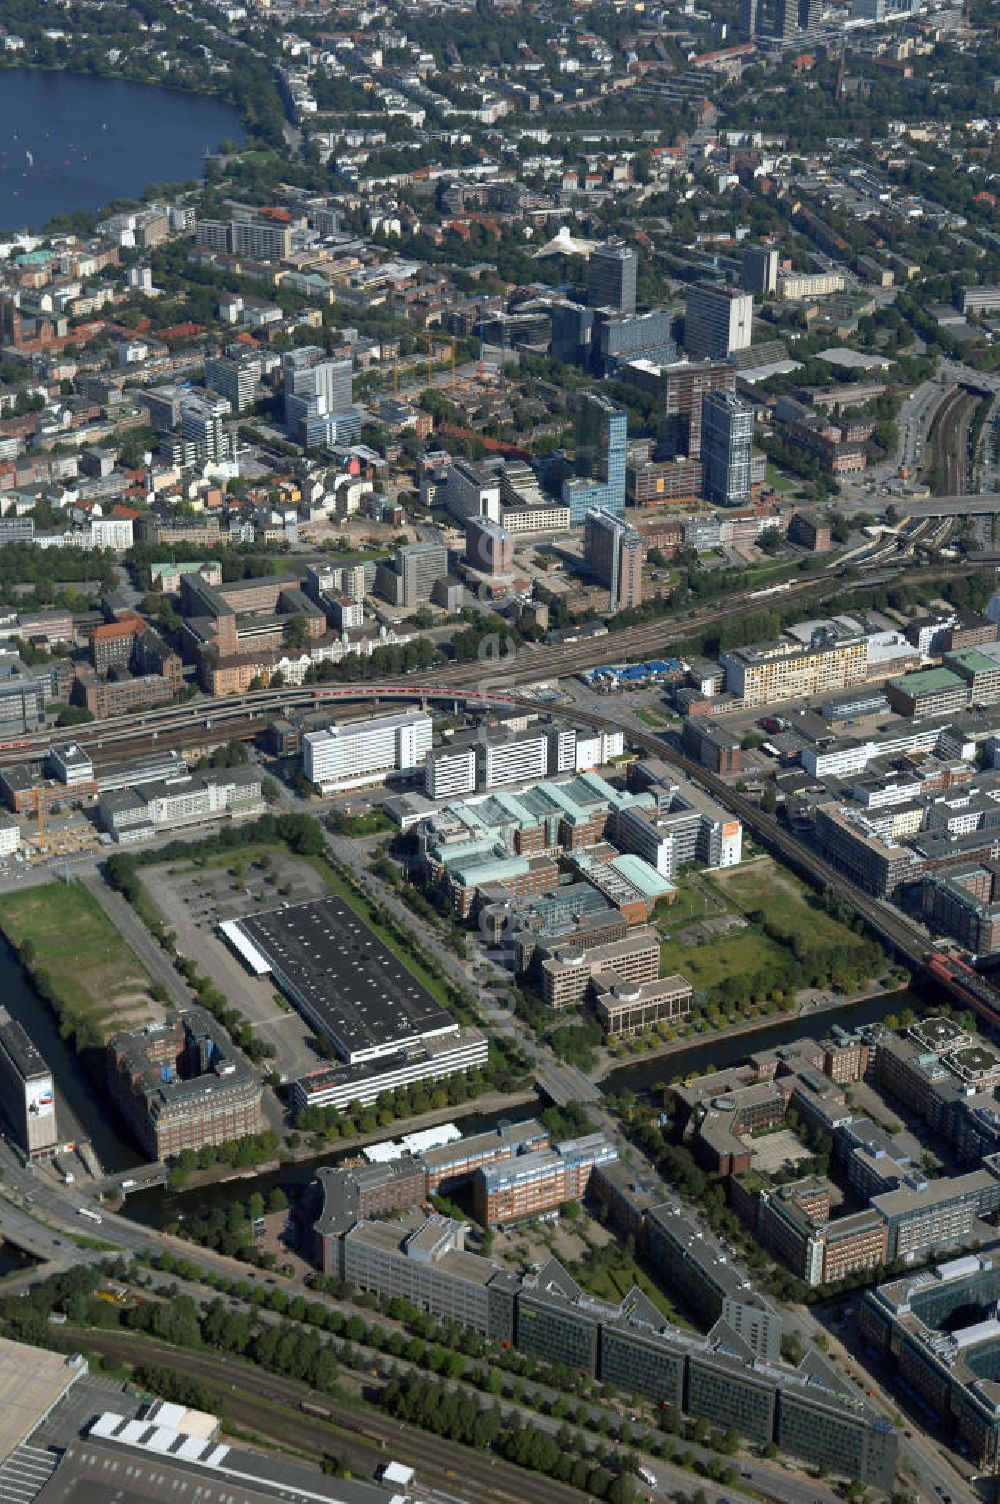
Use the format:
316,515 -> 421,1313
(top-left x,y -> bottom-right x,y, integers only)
306,1185 -> 898,1492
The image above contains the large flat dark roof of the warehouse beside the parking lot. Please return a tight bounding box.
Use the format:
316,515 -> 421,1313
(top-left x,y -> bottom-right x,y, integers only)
239,898 -> 454,1060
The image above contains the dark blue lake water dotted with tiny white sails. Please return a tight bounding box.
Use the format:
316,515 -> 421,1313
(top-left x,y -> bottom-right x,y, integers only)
0,68 -> 242,230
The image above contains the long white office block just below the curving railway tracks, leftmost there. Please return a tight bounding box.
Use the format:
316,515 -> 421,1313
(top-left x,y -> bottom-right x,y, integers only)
302,710 -> 433,790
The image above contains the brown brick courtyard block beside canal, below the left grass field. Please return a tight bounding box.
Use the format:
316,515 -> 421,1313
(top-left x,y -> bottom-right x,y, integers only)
107,1008 -> 265,1161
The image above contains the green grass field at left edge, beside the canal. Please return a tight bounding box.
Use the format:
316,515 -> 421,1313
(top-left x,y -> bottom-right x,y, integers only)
0,883 -> 150,1039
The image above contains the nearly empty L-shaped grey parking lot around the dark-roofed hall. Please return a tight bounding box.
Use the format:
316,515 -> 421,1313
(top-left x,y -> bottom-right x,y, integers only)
143,851 -> 325,1080
